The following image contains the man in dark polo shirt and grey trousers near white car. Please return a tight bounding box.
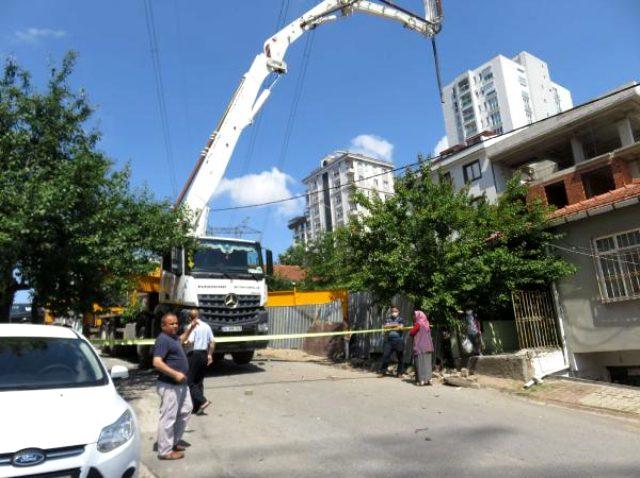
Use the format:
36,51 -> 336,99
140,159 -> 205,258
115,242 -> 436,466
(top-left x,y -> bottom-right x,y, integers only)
153,312 -> 193,460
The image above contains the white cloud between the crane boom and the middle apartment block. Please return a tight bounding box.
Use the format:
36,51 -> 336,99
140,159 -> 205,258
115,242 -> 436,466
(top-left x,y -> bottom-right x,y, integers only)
213,168 -> 304,216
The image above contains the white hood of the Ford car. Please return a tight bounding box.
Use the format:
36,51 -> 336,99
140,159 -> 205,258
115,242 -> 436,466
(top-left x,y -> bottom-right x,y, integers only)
0,383 -> 127,454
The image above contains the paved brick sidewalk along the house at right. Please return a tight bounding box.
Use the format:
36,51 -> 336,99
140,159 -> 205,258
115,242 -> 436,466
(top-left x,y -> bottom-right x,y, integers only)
477,375 -> 640,418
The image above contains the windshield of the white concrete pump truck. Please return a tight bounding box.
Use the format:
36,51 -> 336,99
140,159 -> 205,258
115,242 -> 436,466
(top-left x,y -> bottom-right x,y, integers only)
191,239 -> 263,275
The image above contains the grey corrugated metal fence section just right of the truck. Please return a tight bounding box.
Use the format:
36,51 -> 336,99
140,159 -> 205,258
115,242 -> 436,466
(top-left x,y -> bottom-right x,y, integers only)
267,300 -> 342,349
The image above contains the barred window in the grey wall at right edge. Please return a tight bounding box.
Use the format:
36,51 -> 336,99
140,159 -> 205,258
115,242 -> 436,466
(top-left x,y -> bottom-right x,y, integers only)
593,229 -> 640,302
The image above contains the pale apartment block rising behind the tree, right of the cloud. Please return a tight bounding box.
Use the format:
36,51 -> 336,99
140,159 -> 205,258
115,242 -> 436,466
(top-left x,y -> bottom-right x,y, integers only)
303,151 -> 394,241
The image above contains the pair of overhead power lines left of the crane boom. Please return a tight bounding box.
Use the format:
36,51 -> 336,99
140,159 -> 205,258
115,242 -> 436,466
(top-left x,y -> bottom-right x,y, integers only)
144,0 -> 178,196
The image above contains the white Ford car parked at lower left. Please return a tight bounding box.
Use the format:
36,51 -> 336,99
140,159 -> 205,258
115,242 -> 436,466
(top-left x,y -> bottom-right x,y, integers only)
0,324 -> 140,478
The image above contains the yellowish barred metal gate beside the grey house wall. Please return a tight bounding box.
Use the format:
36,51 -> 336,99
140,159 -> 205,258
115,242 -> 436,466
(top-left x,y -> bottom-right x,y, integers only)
511,291 -> 561,349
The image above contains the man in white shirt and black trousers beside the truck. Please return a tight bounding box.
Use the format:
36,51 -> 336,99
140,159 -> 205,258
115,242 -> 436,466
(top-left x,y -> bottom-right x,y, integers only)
186,309 -> 216,415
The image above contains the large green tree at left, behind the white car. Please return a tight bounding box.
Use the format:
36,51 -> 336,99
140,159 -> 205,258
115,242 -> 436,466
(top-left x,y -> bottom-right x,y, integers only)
0,54 -> 190,321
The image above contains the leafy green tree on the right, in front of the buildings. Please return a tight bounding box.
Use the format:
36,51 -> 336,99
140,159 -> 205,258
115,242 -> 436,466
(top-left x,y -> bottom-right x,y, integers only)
344,163 -> 573,321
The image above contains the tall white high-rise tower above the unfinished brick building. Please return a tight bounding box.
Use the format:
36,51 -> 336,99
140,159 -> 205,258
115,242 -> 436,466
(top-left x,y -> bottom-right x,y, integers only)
443,51 -> 573,146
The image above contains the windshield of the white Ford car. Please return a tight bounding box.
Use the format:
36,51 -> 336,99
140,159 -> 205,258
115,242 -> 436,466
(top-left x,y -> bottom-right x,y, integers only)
0,337 -> 107,391
